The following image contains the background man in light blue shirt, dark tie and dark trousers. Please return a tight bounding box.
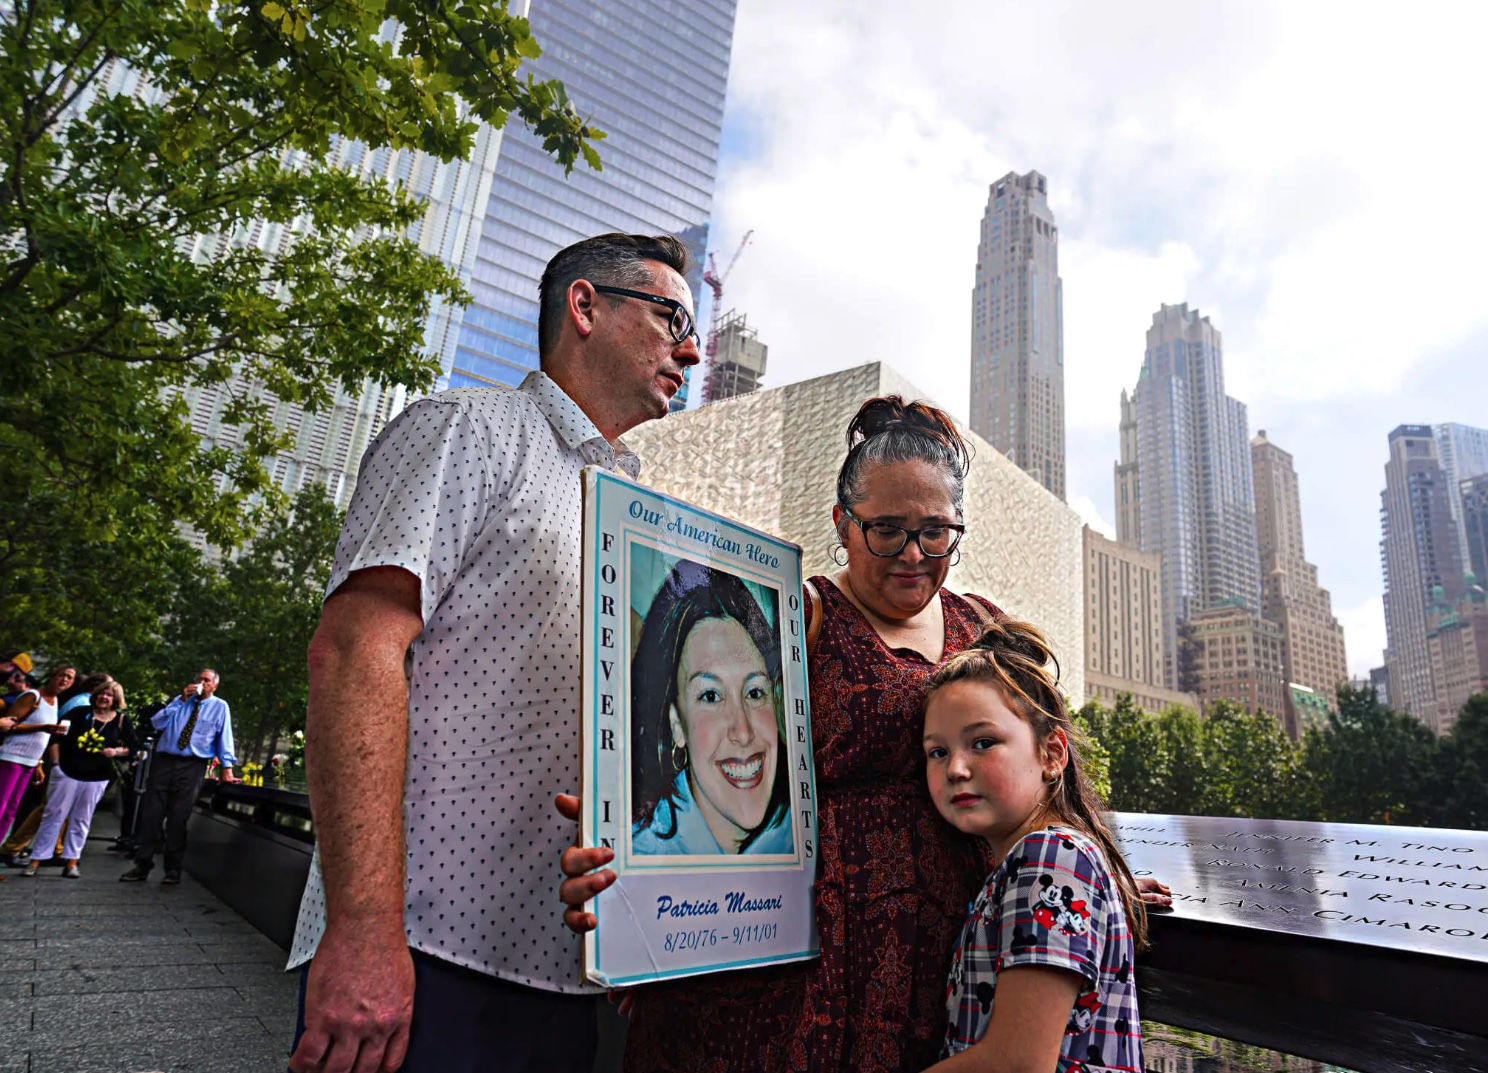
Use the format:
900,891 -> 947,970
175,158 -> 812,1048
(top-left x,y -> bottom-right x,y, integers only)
119,670 -> 241,884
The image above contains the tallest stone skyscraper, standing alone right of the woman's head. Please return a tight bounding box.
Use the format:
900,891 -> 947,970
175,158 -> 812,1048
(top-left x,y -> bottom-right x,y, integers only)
972,171 -> 1064,499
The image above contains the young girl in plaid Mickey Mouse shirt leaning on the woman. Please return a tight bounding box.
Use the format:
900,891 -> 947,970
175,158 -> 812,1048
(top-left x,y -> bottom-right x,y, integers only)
924,619 -> 1147,1073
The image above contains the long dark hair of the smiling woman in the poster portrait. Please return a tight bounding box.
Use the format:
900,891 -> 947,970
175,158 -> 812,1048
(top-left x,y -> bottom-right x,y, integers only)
631,560 -> 790,853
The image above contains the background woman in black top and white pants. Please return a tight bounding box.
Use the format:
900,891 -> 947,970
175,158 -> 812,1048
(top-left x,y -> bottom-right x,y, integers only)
22,682 -> 135,880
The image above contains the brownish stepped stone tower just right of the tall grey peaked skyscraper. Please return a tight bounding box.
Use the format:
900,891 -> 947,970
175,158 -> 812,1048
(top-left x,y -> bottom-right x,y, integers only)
1250,432 -> 1348,737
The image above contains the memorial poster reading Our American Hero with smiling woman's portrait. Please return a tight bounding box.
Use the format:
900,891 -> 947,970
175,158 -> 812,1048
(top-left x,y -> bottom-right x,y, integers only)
580,467 -> 817,987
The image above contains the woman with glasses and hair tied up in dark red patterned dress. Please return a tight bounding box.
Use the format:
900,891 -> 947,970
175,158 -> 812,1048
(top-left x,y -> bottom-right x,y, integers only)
562,396 -> 995,1073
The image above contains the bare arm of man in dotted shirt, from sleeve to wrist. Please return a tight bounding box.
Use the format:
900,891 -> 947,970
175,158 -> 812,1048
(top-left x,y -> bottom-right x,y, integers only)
305,580 -> 417,924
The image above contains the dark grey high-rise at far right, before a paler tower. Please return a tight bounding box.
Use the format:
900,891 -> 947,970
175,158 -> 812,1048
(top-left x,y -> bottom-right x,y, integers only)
1379,424 -> 1464,729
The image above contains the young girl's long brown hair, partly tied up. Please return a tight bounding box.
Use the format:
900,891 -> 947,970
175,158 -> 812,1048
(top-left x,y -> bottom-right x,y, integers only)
926,616 -> 1147,949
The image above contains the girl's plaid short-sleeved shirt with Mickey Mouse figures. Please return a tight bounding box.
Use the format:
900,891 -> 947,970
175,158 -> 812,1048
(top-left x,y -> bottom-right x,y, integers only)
940,826 -> 1143,1073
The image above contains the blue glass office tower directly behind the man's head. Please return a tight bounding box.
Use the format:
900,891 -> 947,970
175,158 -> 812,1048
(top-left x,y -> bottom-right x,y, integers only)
448,0 -> 735,409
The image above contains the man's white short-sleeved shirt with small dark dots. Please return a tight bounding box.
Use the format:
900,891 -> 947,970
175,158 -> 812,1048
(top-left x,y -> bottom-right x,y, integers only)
289,372 -> 640,993
